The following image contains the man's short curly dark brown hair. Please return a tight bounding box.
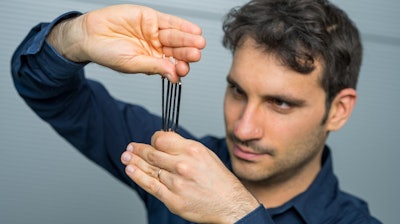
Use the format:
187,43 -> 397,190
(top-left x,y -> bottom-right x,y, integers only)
223,0 -> 362,115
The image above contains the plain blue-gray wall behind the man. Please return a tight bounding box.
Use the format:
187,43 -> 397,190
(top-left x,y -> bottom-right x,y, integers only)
0,0 -> 400,224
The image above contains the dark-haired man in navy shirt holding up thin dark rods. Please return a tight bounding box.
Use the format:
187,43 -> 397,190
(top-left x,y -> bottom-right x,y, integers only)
12,0 -> 379,224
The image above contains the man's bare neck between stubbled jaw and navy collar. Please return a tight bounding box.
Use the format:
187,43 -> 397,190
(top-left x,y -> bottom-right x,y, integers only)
242,152 -> 322,208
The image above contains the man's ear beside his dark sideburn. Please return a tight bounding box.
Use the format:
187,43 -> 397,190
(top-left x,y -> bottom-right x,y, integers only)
326,88 -> 357,131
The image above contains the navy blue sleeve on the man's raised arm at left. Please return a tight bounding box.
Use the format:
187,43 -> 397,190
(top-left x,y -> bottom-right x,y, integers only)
11,12 -> 161,192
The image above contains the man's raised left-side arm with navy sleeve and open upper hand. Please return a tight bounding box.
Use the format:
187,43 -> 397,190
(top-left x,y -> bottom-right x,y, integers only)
11,5 -> 205,196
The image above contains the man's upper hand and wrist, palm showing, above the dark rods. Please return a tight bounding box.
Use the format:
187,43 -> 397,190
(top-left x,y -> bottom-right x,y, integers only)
47,5 -> 206,82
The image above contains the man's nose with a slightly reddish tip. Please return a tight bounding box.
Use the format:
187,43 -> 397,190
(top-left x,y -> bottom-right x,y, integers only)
234,105 -> 264,141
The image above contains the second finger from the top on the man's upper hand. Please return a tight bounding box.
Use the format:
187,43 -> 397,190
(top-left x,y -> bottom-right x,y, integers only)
159,29 -> 206,49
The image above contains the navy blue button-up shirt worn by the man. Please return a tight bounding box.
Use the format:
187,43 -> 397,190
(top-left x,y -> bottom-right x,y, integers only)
12,12 -> 380,224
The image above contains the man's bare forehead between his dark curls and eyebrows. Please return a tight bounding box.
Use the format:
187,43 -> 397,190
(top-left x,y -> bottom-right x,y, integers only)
229,38 -> 324,95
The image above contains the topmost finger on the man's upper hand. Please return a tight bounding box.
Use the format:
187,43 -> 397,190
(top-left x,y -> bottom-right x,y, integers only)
158,13 -> 202,35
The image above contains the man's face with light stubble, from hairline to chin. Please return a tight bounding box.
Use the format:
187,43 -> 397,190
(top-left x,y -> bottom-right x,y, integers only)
224,39 -> 327,183
